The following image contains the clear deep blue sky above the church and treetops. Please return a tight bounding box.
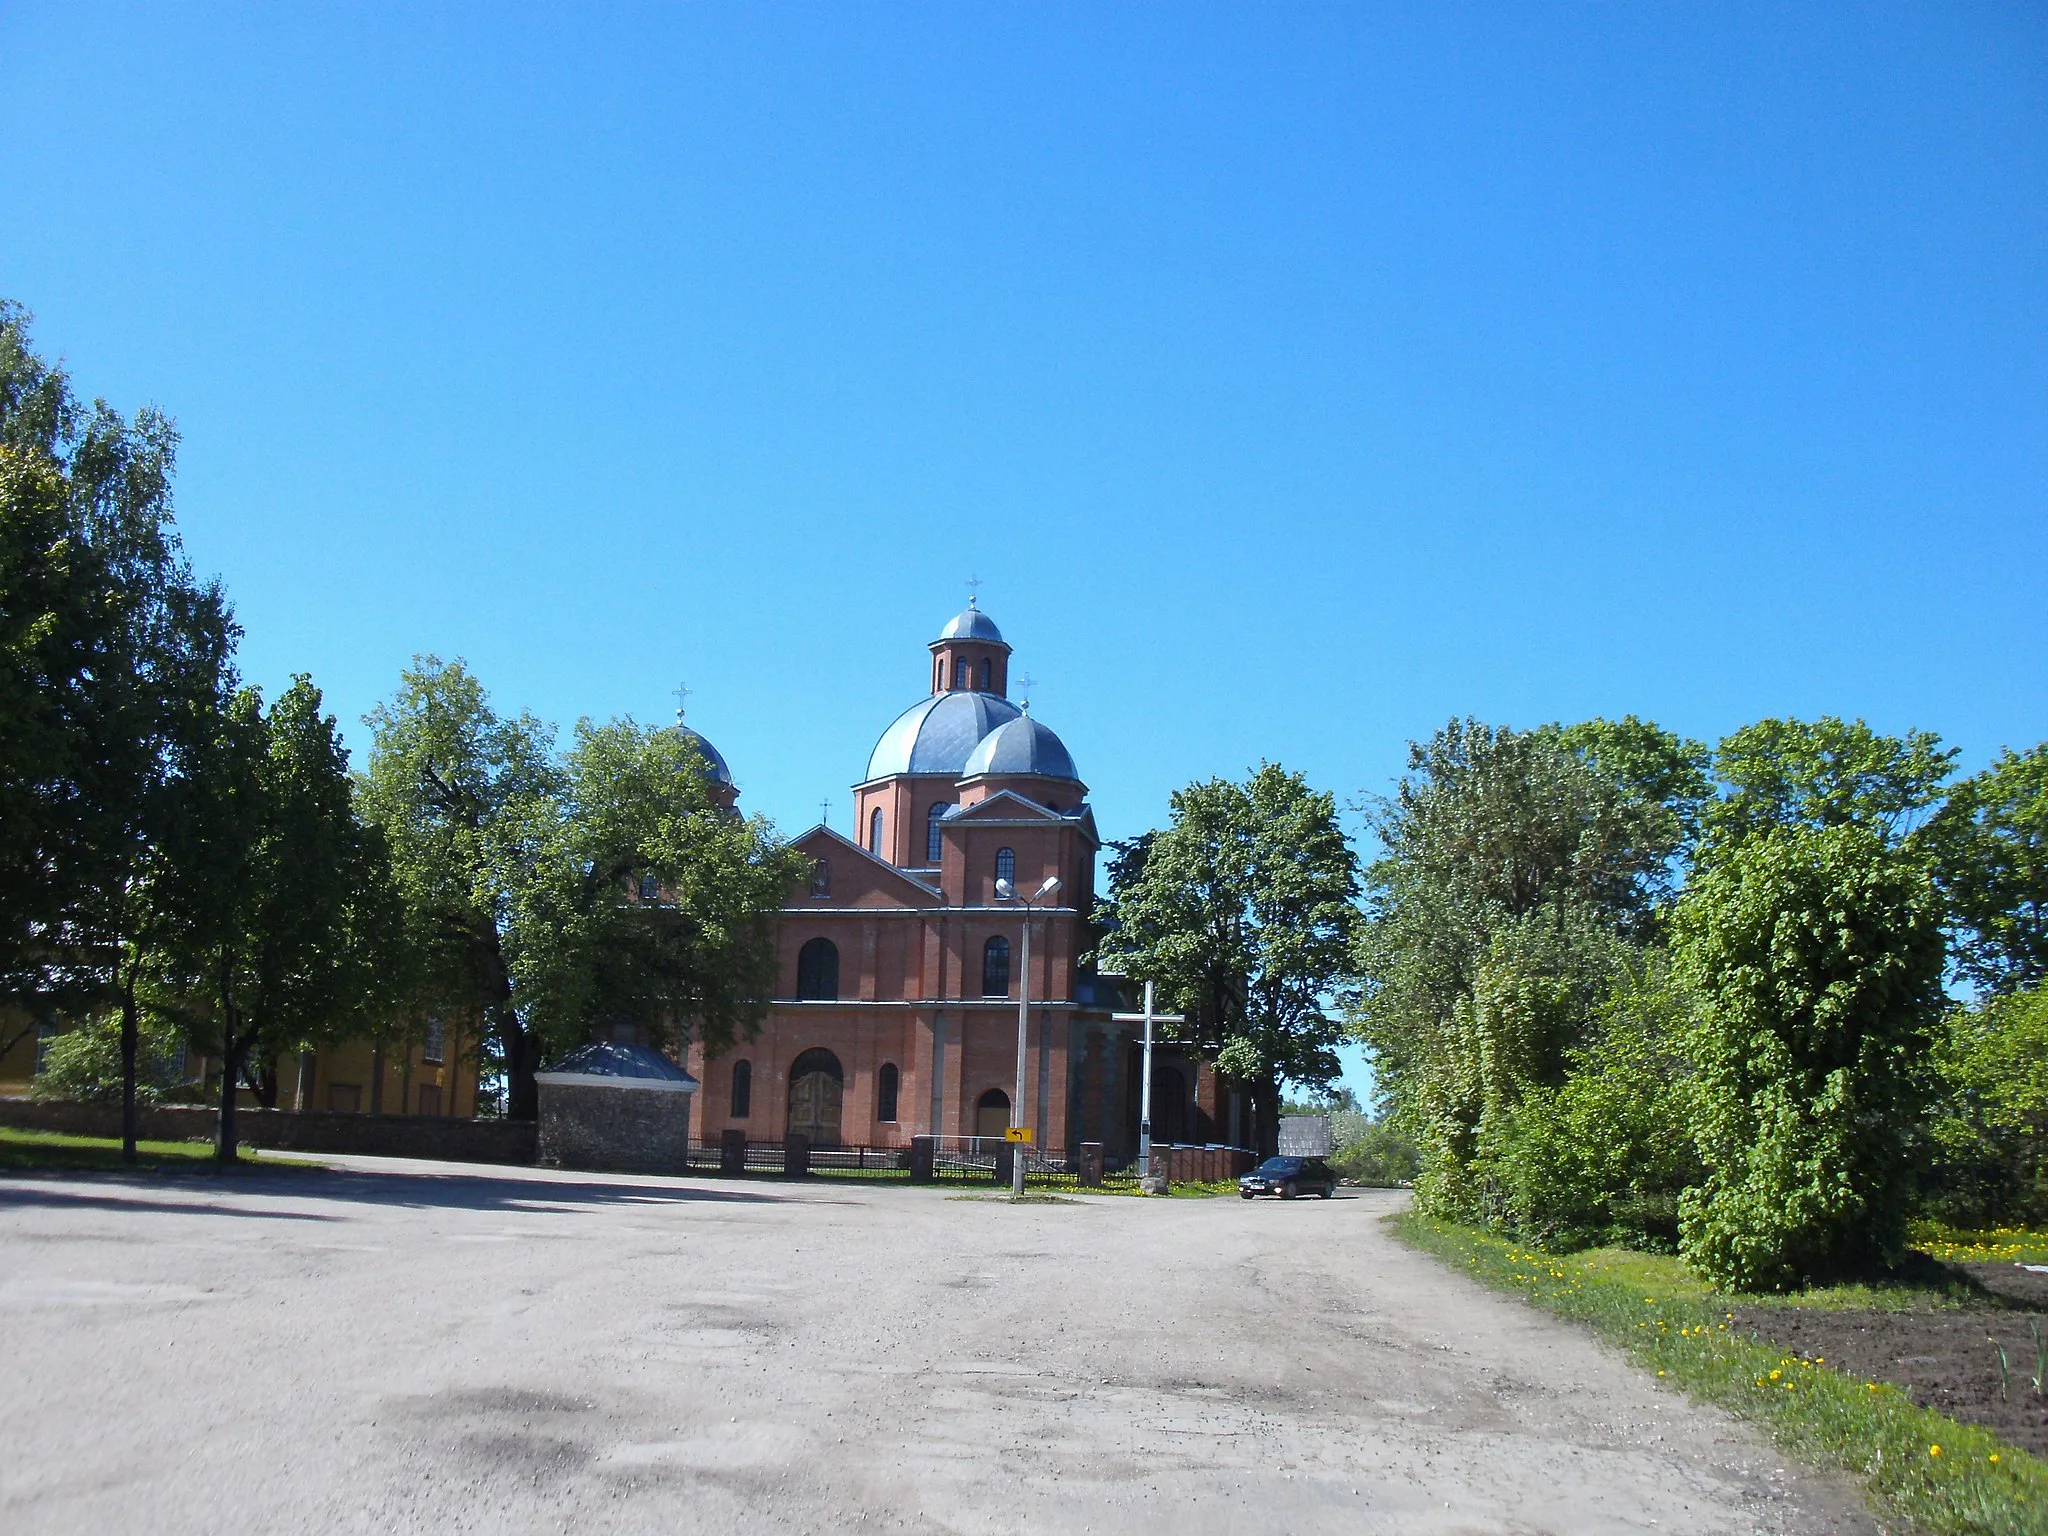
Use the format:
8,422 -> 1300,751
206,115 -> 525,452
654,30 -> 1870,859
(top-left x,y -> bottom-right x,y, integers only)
0,0 -> 2048,1105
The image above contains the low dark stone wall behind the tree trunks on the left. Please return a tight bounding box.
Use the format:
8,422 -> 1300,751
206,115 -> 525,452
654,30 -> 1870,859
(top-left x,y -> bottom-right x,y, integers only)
0,1098 -> 535,1163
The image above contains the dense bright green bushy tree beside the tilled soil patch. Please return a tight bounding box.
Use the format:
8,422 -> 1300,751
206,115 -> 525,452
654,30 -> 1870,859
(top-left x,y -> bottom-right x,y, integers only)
1673,823 -> 1944,1290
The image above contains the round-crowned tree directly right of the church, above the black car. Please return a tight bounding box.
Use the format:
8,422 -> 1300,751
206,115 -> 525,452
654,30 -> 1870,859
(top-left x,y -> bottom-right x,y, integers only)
1098,764 -> 1358,1153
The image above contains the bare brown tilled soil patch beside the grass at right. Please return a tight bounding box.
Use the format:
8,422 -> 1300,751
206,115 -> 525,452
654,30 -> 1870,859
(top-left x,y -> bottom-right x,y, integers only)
1731,1266 -> 2048,1456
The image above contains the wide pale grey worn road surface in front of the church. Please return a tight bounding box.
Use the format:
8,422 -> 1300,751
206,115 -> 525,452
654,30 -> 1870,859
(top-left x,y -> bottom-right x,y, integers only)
0,1159 -> 1874,1536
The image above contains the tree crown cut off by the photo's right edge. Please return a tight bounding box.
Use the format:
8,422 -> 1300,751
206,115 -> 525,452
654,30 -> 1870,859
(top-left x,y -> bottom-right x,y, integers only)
1933,741 -> 2048,993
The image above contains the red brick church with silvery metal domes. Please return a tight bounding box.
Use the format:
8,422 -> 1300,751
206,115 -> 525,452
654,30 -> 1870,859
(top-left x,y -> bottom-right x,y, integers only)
686,602 -> 1245,1159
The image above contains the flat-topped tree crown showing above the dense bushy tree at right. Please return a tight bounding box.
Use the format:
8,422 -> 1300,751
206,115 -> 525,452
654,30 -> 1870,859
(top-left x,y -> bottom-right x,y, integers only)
1704,715 -> 1956,850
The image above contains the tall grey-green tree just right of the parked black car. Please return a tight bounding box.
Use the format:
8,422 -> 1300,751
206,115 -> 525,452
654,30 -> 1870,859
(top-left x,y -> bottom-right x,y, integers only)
1354,721 -> 1698,1217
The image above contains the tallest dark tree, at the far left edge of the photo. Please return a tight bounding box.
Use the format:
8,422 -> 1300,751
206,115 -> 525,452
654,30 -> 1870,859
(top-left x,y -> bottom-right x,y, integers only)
0,301 -> 238,1159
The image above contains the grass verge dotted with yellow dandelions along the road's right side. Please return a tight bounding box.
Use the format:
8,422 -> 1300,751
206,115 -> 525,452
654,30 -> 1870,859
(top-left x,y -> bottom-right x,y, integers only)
1389,1212 -> 2048,1536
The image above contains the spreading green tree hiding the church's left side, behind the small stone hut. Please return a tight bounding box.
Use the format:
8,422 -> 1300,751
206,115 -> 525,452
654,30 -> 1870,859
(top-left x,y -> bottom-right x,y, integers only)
365,657 -> 807,1118
